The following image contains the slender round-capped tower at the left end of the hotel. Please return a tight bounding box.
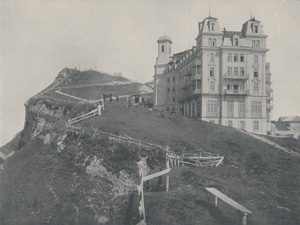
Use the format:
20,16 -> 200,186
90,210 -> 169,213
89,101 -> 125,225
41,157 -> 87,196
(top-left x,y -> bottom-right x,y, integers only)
154,35 -> 172,109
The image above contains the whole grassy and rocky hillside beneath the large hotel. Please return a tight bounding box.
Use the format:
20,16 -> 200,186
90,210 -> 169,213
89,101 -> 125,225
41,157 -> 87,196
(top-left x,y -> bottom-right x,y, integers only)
0,68 -> 300,225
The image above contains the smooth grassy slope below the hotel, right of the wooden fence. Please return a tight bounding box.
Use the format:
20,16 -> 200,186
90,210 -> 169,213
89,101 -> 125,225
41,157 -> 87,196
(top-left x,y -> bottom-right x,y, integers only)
77,102 -> 300,224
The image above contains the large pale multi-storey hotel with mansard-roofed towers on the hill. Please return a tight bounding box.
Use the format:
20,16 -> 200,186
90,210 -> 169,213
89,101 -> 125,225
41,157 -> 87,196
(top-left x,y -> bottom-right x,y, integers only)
154,17 -> 273,134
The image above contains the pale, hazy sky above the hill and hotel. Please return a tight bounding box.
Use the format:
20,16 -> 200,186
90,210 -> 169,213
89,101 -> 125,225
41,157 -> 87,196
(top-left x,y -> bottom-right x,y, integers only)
0,0 -> 300,146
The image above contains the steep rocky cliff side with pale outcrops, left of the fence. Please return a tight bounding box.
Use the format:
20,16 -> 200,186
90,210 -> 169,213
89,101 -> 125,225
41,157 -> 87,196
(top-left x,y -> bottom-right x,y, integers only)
0,69 -> 158,225
